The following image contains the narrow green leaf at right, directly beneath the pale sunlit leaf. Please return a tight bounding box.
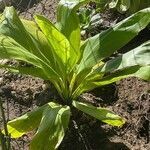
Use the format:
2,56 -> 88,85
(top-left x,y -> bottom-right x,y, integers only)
73,66 -> 150,98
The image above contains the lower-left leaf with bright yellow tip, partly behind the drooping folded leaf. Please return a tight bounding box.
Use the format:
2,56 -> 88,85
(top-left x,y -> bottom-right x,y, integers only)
7,105 -> 48,138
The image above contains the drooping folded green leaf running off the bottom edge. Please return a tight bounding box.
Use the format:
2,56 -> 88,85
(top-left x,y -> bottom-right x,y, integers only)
30,103 -> 70,150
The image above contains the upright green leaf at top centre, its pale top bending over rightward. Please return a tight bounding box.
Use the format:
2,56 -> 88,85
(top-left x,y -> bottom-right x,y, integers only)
57,0 -> 89,51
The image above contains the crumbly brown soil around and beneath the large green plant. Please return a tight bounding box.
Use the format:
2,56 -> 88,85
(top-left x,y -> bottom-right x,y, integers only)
0,0 -> 150,150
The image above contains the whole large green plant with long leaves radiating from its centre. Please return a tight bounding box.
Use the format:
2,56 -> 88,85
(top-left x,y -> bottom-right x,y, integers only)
0,0 -> 150,150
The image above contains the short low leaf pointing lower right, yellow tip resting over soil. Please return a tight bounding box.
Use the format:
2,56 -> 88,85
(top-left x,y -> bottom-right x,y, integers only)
72,101 -> 125,126
